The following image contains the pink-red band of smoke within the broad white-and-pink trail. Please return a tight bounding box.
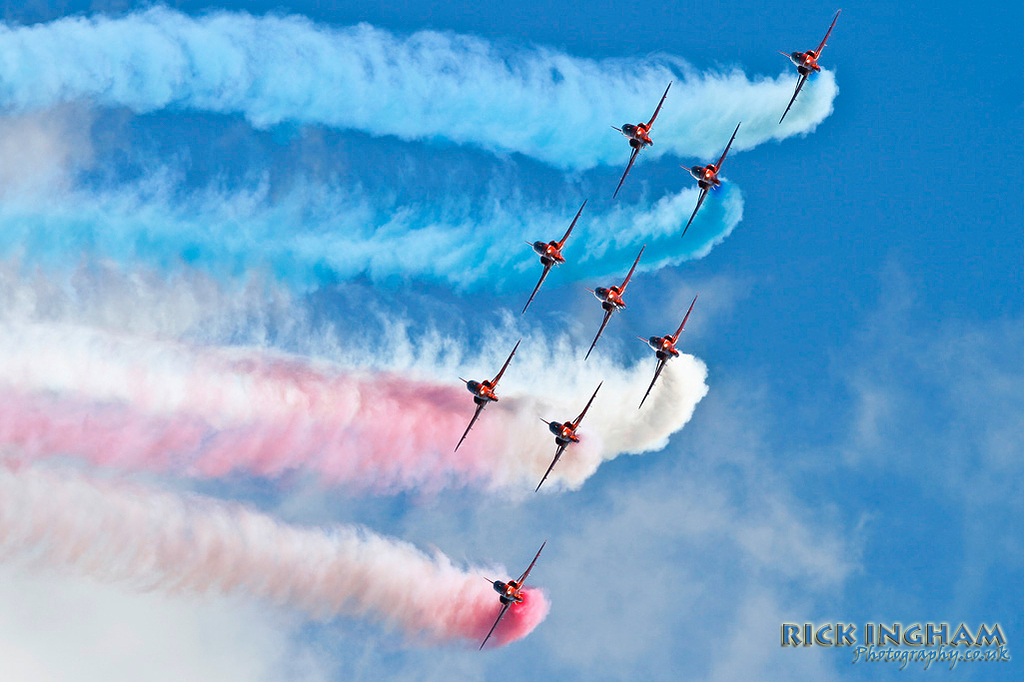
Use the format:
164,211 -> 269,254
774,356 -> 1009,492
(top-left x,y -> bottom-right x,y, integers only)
0,378 -> 507,491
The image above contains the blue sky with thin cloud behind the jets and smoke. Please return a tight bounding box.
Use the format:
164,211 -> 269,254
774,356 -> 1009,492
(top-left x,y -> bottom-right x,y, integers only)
4,2 -> 1024,679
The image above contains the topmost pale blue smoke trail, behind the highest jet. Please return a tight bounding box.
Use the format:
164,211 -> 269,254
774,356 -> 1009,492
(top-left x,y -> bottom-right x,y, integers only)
0,7 -> 838,169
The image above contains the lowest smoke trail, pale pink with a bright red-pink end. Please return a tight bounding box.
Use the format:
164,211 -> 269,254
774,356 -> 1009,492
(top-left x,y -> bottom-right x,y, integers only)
0,466 -> 549,644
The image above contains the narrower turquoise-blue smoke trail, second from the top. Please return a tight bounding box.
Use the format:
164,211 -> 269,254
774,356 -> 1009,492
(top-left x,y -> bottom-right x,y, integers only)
0,171 -> 742,292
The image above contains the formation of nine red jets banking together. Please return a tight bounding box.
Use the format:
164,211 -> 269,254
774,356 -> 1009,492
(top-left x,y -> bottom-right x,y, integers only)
456,10 -> 842,649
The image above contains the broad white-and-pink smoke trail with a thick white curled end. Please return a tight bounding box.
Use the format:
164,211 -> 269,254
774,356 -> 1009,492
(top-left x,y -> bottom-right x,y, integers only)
0,325 -> 708,492
